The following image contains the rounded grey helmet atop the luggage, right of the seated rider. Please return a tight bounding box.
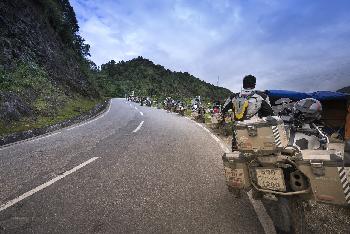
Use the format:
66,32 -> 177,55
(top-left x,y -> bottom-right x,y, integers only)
293,98 -> 322,123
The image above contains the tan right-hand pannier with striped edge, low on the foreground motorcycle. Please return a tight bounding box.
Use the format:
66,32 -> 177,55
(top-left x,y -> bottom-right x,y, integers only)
297,150 -> 350,206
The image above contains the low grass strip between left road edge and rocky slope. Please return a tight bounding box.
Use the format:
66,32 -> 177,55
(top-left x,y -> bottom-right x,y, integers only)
0,97 -> 102,136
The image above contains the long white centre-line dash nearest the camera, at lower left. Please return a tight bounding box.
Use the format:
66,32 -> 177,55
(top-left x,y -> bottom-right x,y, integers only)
0,157 -> 99,211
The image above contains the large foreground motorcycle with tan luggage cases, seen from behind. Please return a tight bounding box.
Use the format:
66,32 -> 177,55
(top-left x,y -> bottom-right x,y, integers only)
222,98 -> 350,233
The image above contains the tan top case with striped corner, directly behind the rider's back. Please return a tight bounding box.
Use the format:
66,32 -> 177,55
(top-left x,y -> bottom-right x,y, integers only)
234,116 -> 288,155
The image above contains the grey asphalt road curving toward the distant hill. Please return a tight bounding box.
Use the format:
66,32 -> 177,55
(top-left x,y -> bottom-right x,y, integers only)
0,99 -> 264,233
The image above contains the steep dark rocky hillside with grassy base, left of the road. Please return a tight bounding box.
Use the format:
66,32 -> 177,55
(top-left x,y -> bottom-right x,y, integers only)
0,0 -> 100,135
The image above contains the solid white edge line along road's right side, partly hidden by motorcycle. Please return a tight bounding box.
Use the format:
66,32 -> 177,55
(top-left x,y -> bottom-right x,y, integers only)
185,117 -> 276,234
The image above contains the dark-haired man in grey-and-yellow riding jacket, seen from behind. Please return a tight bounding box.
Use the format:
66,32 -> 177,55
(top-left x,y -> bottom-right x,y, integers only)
222,75 -> 273,121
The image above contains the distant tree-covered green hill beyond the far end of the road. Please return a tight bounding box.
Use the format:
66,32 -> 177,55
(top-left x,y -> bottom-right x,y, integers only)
97,57 -> 231,100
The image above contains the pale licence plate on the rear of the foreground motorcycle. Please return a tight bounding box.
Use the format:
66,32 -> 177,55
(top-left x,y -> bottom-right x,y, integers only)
255,168 -> 286,192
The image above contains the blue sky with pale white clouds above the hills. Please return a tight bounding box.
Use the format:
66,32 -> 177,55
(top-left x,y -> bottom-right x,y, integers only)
70,0 -> 350,92
